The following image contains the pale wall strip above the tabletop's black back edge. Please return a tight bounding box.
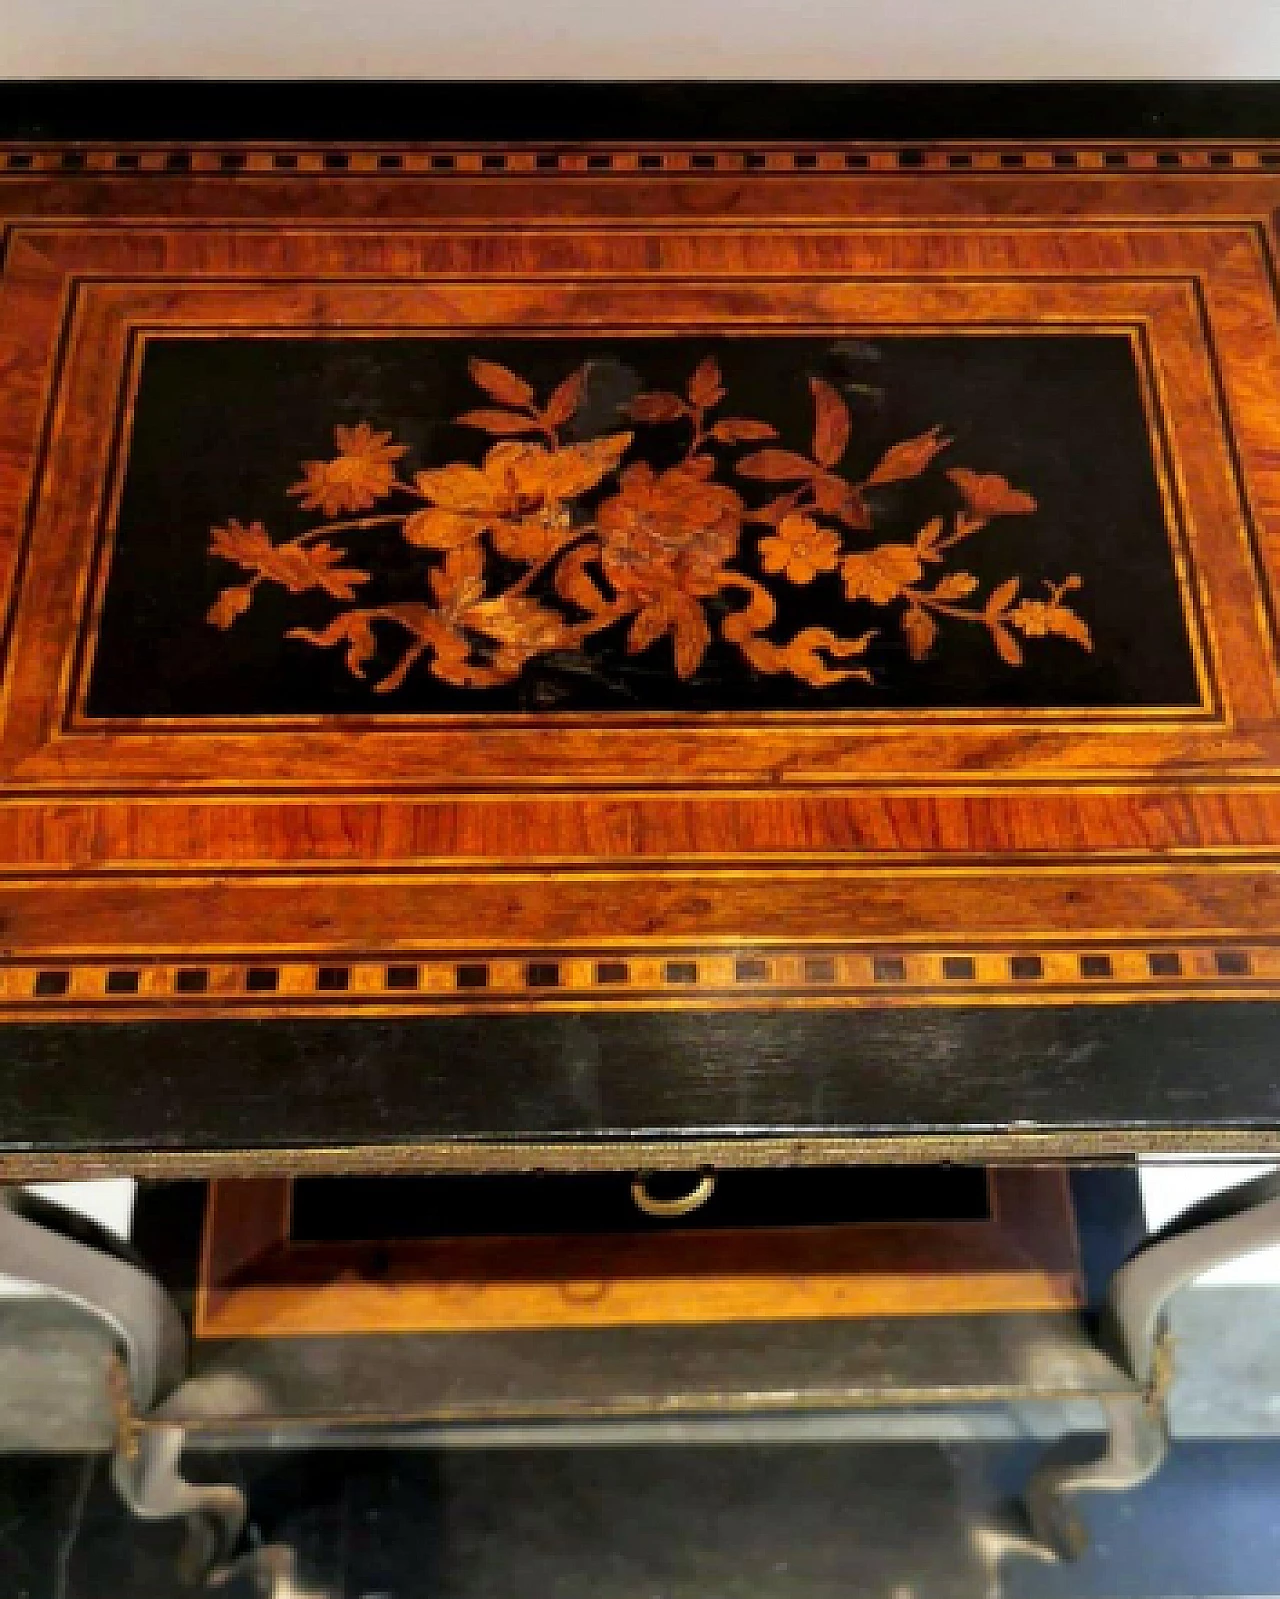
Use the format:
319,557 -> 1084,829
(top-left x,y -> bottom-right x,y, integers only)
0,0 -> 1280,78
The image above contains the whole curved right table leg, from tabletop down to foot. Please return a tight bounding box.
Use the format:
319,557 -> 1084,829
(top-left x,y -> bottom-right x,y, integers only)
1026,1172 -> 1280,1559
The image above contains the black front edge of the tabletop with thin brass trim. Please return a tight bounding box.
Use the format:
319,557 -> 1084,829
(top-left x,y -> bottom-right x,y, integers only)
0,1003 -> 1280,1174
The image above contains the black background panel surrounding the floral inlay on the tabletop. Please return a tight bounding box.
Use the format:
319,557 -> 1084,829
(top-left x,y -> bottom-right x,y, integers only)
86,334 -> 1199,718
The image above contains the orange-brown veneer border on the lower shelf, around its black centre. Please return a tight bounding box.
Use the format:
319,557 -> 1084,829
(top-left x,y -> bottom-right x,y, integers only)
195,1169 -> 1082,1338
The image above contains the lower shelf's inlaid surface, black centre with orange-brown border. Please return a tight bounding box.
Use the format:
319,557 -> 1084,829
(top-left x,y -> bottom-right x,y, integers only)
197,1167 -> 1082,1337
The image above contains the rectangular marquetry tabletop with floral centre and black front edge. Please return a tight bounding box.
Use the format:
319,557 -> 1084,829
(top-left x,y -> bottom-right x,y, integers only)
0,127 -> 1280,1172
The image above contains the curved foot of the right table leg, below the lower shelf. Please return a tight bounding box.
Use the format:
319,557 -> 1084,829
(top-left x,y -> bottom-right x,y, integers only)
1024,1394 -> 1168,1561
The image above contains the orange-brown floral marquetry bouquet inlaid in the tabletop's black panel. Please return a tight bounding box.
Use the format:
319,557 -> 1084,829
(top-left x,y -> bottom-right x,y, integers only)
208,357 -> 1093,694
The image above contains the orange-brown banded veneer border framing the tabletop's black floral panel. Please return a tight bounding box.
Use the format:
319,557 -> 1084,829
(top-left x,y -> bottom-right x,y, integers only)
0,155 -> 1280,1019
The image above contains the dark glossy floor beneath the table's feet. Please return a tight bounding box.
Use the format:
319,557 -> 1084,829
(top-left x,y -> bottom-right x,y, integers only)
0,1439 -> 1280,1599
